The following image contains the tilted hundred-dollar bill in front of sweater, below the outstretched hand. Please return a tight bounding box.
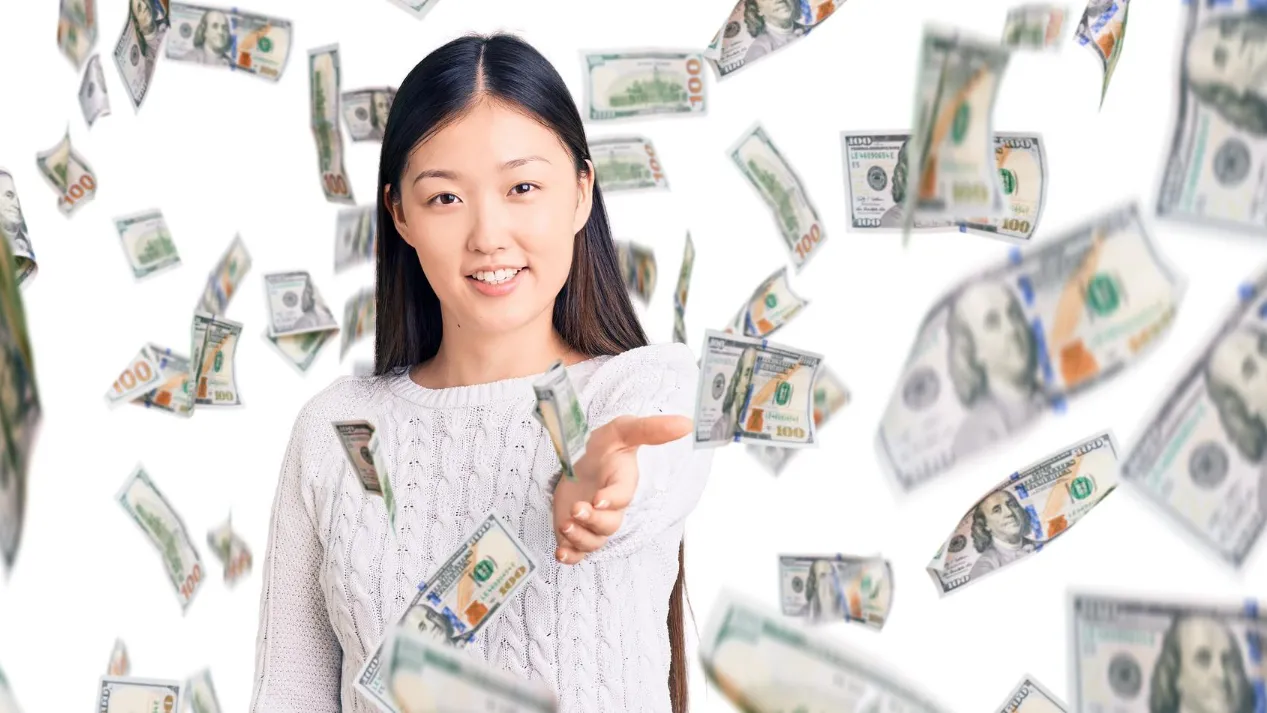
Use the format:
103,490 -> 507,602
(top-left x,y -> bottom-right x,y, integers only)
355,512 -> 537,713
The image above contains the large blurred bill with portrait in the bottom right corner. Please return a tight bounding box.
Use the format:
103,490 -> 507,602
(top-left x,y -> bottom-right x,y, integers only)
1068,593 -> 1267,713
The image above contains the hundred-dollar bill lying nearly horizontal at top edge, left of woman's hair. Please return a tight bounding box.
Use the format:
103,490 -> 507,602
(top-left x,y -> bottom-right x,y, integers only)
167,3 -> 290,81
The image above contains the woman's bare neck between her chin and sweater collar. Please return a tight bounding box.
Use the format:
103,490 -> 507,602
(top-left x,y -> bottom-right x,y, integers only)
409,304 -> 584,389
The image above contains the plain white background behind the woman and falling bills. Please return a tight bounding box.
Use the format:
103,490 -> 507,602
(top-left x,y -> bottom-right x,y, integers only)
0,0 -> 1267,712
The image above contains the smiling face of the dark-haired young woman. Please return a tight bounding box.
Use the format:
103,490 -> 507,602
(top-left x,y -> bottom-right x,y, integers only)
393,101 -> 593,332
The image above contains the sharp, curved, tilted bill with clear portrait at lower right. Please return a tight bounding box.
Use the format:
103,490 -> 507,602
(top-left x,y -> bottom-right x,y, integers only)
929,432 -> 1117,595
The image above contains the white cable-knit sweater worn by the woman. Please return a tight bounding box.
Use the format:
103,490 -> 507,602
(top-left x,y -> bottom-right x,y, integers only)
241,344 -> 712,713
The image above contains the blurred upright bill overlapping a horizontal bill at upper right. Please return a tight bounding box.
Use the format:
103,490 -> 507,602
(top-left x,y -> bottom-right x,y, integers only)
902,27 -> 1009,227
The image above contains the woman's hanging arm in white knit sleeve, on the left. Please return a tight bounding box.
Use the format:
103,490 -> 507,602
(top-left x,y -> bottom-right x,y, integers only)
251,405 -> 343,713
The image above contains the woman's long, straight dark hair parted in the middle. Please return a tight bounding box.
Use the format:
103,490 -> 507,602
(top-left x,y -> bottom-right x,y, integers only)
374,34 -> 687,713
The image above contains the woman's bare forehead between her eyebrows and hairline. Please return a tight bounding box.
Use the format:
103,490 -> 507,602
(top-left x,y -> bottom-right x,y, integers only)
409,100 -> 570,174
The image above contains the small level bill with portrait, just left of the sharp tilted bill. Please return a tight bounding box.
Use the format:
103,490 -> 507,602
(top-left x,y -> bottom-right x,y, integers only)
779,555 -> 893,629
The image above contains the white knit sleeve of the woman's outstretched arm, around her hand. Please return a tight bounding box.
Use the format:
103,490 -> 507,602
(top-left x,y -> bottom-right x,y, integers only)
585,344 -> 715,562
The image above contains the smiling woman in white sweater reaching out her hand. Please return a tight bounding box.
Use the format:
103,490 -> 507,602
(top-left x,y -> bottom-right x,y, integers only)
252,35 -> 711,713
